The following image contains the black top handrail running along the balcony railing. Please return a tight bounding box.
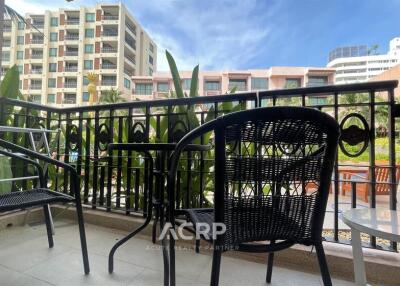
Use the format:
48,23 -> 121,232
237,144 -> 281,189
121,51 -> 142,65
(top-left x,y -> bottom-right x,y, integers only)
0,80 -> 398,113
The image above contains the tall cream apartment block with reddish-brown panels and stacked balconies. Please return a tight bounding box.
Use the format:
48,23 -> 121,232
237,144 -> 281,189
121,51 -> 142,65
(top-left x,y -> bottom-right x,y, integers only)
2,4 -> 157,106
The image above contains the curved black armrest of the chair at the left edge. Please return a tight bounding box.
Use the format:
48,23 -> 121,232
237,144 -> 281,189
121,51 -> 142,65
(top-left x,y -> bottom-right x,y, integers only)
0,139 -> 79,197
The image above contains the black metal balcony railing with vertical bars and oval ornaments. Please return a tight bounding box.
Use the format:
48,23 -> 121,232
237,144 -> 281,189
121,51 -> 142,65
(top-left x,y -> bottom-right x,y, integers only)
0,81 -> 400,250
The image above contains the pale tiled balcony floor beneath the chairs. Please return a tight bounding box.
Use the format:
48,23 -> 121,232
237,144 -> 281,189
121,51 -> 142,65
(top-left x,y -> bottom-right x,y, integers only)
0,219 -> 353,286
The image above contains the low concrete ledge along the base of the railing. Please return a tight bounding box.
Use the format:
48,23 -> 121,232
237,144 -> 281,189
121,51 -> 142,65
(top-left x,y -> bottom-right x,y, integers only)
0,206 -> 400,285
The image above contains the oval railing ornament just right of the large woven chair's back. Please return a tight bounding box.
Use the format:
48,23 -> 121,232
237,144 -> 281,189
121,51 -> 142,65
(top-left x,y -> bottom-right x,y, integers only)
339,113 -> 370,157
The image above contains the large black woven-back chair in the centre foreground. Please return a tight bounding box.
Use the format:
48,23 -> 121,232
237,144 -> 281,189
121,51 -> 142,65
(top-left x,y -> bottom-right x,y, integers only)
168,107 -> 339,286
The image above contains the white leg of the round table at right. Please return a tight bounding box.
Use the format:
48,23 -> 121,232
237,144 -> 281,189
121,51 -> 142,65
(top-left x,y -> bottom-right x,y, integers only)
351,228 -> 368,286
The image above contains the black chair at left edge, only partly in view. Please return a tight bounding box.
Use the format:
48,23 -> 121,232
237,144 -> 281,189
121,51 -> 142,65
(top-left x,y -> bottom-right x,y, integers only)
0,139 -> 90,274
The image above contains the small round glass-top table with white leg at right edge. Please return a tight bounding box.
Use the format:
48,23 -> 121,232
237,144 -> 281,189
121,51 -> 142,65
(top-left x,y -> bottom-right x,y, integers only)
341,208 -> 400,285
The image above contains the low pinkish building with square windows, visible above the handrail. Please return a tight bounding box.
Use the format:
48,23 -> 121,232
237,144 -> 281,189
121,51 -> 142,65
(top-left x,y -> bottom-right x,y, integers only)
132,67 -> 335,100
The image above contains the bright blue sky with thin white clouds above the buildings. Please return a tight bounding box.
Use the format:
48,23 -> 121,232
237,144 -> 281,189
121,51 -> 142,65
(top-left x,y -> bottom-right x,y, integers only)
6,0 -> 400,70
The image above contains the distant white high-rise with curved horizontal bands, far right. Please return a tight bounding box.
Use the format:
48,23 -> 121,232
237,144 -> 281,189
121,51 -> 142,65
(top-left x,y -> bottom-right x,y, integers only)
327,37 -> 400,84
